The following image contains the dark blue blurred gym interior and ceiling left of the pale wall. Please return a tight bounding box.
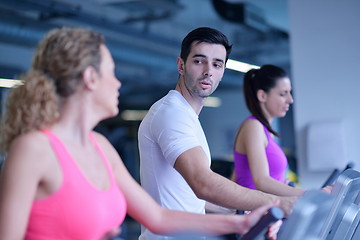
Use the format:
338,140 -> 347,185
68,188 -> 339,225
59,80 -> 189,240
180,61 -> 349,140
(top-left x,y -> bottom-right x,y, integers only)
0,0 -> 294,179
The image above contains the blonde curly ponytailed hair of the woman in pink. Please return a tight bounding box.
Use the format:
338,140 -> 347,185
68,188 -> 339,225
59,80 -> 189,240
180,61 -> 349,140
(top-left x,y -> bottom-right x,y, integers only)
0,27 -> 105,154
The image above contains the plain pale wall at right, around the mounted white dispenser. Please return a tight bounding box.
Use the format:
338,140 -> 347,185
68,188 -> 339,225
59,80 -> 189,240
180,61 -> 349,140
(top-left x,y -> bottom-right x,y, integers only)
289,0 -> 360,188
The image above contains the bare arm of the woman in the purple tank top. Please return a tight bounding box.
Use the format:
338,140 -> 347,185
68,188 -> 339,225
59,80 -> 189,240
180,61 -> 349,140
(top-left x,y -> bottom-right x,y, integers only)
235,120 -> 304,196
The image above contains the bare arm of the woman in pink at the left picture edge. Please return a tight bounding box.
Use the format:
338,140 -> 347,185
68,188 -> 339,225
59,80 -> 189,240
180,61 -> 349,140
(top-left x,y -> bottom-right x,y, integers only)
0,134 -> 49,240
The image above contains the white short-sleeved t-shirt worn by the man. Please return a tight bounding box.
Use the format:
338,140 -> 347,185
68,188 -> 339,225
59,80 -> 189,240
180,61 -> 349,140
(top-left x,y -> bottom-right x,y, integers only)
138,90 -> 211,240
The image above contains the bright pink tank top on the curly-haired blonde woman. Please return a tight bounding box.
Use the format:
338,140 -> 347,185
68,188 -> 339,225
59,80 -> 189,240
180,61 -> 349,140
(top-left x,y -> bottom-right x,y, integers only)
25,130 -> 126,240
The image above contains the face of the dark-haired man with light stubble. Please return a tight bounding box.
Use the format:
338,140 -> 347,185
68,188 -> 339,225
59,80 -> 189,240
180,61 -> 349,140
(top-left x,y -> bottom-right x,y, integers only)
180,42 -> 226,98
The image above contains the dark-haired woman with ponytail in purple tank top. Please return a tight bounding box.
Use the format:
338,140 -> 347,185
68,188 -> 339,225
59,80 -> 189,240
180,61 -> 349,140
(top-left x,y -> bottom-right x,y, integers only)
232,65 -> 304,196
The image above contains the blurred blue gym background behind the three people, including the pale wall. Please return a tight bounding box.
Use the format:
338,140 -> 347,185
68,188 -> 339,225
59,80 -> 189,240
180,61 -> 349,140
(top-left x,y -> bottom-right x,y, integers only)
0,0 -> 360,239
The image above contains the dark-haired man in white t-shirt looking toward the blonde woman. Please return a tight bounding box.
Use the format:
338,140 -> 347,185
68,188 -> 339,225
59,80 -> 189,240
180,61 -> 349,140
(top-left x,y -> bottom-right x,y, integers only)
138,27 -> 296,240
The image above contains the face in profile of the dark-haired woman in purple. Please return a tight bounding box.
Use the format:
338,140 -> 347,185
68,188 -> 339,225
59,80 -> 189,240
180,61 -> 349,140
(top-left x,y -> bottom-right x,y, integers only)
260,77 -> 293,121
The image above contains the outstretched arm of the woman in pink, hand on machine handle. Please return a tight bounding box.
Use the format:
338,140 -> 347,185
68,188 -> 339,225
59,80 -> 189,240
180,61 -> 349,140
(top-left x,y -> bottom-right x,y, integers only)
94,133 -> 274,235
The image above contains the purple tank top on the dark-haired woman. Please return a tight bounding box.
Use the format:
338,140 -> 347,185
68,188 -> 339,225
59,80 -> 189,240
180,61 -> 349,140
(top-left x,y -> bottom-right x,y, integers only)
234,116 -> 287,189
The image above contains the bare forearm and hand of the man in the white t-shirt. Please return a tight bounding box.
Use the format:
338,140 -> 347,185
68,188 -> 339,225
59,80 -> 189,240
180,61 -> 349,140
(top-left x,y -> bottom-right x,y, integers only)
174,146 -> 296,214
